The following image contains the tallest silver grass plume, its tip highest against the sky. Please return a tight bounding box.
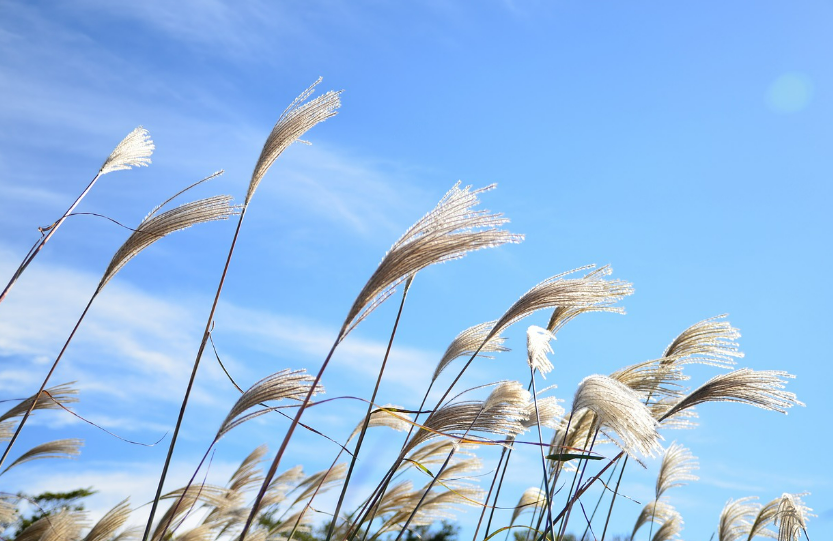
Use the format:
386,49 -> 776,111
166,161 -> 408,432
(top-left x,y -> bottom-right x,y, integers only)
245,77 -> 341,205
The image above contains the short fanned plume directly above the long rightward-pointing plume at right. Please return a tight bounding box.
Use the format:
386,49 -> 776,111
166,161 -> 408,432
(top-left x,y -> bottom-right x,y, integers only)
659,314 -> 743,368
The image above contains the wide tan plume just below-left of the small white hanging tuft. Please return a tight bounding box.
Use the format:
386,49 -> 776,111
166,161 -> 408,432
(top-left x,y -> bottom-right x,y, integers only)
404,381 -> 530,453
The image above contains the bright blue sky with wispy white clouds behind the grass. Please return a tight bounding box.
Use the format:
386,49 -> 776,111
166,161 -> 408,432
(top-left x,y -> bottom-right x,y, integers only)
0,0 -> 833,539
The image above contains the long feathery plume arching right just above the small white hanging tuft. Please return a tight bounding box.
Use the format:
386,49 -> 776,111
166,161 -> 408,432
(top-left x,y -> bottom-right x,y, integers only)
492,266 -> 633,334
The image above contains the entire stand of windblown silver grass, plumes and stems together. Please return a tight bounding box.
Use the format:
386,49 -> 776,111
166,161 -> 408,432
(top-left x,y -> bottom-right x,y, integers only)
0,82 -> 811,541
